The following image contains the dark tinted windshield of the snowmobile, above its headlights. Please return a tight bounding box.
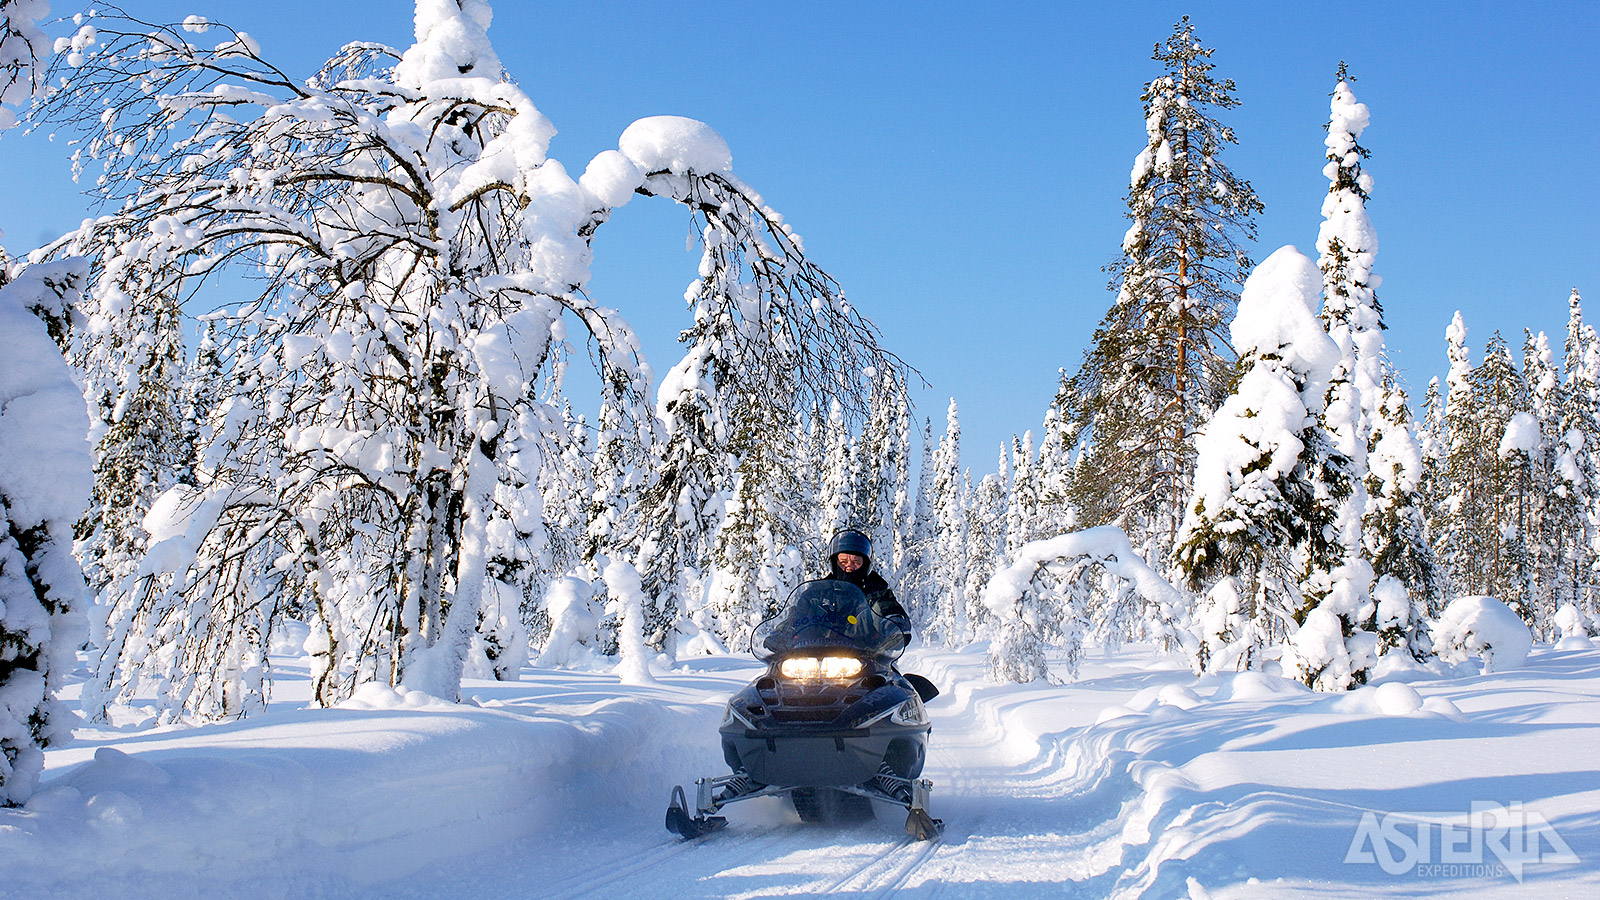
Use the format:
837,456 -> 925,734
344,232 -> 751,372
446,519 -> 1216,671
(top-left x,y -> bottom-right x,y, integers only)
750,580 -> 910,661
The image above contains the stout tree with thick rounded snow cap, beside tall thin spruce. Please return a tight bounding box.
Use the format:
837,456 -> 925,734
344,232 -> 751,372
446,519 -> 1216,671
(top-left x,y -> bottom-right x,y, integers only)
1176,247 -> 1349,675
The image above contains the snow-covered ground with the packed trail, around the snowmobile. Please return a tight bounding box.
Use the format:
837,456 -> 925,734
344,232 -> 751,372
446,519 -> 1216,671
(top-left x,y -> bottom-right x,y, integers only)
0,634 -> 1600,900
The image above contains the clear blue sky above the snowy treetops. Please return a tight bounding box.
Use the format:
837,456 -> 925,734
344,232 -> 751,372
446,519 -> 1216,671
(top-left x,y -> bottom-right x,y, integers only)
0,0 -> 1600,474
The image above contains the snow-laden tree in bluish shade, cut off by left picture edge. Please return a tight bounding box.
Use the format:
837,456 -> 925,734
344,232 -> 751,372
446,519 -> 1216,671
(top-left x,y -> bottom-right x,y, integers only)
0,257 -> 93,797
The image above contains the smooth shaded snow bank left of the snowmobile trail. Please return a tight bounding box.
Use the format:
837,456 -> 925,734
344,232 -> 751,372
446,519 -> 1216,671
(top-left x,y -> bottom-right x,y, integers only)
0,662 -> 725,900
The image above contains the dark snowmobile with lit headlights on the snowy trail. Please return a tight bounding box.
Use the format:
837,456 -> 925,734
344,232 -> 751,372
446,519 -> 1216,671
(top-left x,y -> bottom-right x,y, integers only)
667,580 -> 944,841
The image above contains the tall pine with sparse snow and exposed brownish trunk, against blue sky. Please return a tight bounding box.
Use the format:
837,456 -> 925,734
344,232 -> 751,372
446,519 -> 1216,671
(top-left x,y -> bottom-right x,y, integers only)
1074,16 -> 1262,560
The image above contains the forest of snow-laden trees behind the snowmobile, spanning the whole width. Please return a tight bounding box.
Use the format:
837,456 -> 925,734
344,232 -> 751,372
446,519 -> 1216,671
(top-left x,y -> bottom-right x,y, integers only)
0,0 -> 1600,802
